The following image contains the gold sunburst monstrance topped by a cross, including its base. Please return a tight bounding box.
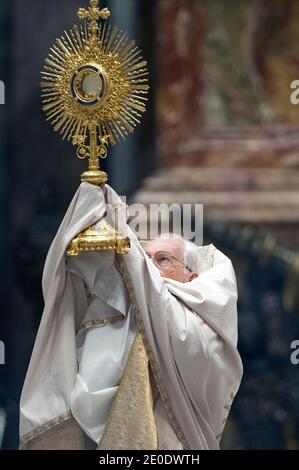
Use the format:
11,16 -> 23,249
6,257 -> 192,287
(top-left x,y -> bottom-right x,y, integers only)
41,0 -> 149,256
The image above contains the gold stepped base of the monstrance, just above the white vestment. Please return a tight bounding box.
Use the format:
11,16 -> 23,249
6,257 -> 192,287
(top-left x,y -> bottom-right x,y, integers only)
66,218 -> 130,256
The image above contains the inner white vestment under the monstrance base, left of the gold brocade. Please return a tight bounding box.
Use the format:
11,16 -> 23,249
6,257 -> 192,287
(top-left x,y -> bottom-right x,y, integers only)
67,253 -> 137,443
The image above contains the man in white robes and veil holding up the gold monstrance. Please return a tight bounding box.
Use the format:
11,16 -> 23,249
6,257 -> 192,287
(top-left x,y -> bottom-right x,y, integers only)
20,183 -> 242,450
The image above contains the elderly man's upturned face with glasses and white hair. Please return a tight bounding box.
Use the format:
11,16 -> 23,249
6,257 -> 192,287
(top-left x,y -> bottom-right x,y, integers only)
144,238 -> 197,282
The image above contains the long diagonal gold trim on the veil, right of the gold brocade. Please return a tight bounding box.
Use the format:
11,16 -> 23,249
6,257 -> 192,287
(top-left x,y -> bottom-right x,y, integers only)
117,256 -> 191,450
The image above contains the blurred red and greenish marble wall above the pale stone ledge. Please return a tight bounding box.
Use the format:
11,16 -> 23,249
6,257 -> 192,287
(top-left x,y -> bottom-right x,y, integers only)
157,0 -> 299,168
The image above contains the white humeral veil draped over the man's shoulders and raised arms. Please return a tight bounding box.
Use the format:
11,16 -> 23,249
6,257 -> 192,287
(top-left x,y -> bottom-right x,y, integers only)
20,183 -> 243,450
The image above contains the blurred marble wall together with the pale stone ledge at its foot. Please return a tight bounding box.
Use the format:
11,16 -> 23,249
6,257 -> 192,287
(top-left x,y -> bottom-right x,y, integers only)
136,0 -> 299,237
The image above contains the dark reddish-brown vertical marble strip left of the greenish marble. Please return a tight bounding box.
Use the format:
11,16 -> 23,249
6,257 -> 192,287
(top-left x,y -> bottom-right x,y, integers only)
155,0 -> 205,166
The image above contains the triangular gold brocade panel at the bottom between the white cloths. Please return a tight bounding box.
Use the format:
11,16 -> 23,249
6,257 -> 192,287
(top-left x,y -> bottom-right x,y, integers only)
97,333 -> 158,450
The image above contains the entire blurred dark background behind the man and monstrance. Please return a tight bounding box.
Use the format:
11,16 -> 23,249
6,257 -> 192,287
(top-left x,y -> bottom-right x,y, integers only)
0,0 -> 299,450
